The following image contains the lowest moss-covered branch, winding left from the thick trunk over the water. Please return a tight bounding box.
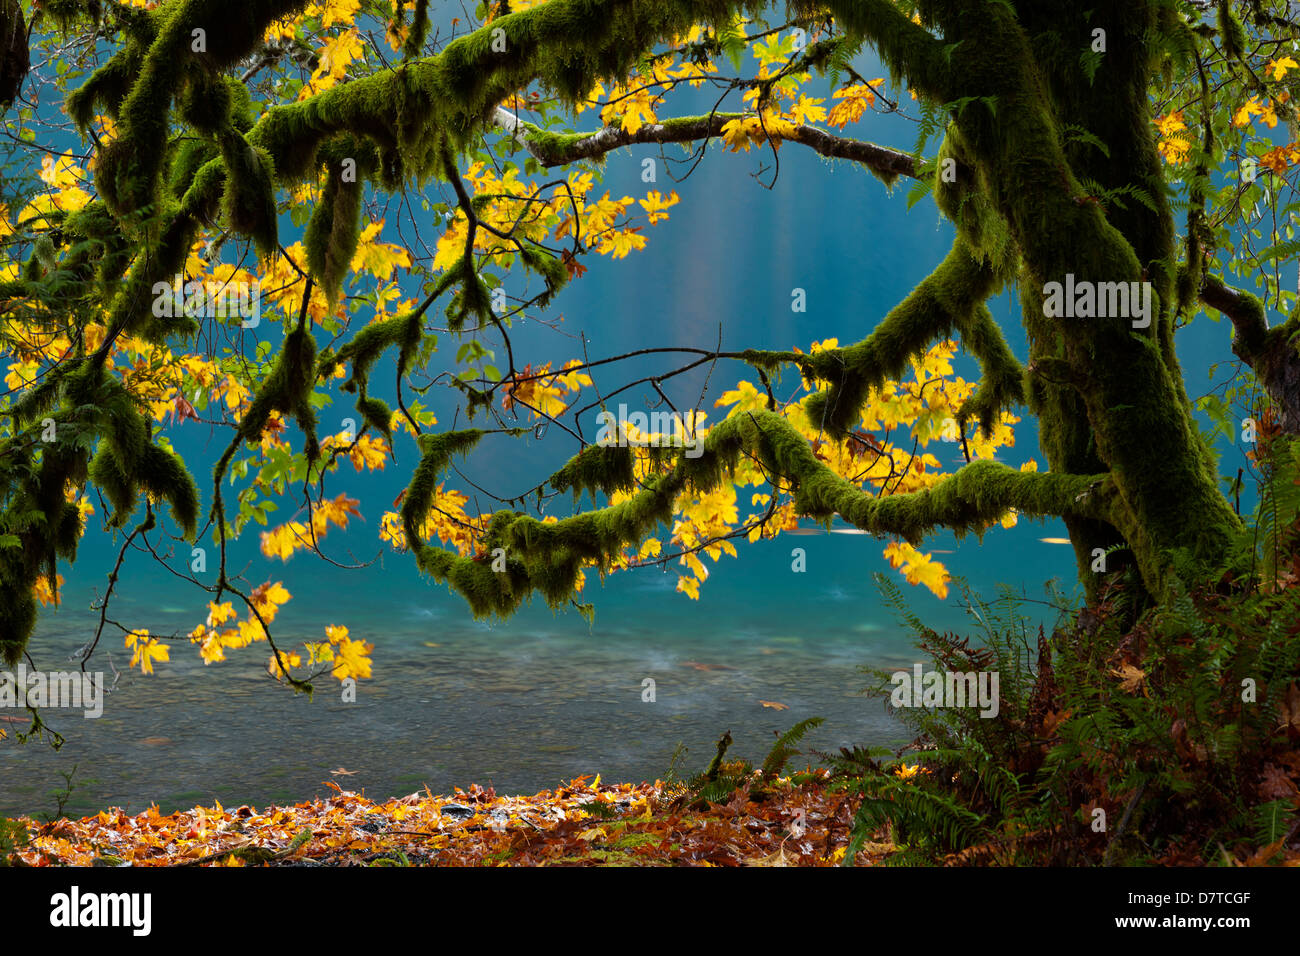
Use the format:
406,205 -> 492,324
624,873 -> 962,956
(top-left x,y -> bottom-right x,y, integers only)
403,411 -> 1115,617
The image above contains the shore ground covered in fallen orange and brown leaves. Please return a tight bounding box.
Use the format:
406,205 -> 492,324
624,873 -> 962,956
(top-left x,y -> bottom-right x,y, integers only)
18,771 -> 893,866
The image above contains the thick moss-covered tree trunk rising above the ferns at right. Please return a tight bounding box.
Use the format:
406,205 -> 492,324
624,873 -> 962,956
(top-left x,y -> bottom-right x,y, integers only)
936,0 -> 1239,592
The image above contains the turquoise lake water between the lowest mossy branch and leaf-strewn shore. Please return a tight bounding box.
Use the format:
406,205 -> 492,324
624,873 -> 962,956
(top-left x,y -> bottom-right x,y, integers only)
0,520 -> 1066,814
